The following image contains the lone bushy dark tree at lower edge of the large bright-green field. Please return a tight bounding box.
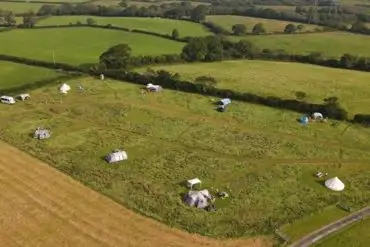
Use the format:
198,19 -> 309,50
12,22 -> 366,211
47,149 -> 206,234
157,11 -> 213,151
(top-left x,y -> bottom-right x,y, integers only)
99,44 -> 131,69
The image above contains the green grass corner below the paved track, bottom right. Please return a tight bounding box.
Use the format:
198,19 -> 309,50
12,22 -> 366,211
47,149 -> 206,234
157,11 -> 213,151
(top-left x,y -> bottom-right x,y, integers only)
313,219 -> 370,247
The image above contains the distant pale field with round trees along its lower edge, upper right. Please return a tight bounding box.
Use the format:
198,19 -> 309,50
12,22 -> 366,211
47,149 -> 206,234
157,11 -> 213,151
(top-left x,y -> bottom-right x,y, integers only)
207,15 -> 318,32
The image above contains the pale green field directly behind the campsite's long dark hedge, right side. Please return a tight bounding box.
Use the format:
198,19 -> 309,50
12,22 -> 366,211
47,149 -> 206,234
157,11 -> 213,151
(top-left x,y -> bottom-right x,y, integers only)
145,60 -> 370,114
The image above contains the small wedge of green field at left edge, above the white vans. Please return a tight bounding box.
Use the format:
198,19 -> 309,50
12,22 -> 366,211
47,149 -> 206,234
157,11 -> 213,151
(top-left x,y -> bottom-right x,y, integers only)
0,61 -> 58,91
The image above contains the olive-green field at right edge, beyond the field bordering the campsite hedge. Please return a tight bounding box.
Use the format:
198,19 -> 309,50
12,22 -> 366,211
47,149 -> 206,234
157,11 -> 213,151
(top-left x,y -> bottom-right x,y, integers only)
231,32 -> 370,58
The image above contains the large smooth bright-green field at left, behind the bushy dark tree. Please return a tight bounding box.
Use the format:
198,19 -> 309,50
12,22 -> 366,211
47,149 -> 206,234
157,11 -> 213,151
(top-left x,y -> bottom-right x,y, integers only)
0,27 -> 184,64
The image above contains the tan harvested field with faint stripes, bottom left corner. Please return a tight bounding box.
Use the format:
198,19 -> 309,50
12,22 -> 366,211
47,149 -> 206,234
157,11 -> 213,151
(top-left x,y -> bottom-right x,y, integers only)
0,142 -> 269,247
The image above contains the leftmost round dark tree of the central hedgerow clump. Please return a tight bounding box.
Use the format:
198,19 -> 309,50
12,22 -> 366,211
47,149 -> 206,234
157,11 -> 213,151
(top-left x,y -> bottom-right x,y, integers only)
181,38 -> 208,61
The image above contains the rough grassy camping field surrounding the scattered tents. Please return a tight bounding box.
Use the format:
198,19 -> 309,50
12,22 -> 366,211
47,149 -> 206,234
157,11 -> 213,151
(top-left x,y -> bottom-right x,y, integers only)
0,78 -> 370,237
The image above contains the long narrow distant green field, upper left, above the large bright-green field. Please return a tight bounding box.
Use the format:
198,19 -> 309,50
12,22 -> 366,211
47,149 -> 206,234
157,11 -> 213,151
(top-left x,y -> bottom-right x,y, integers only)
38,16 -> 210,37
